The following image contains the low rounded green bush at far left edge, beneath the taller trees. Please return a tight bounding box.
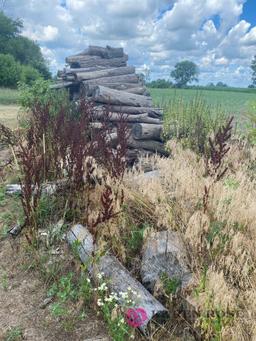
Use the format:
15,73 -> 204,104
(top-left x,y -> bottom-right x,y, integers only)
0,54 -> 21,88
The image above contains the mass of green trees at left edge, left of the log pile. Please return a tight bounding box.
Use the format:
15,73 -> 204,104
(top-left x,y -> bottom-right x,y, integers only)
0,11 -> 51,88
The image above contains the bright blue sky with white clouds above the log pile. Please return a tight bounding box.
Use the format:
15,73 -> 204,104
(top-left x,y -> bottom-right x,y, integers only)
5,0 -> 256,86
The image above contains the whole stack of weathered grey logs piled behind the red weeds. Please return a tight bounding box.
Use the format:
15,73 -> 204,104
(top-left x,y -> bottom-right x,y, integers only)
53,46 -> 166,163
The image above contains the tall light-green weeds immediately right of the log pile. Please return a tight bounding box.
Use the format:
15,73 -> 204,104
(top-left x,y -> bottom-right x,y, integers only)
164,96 -> 225,155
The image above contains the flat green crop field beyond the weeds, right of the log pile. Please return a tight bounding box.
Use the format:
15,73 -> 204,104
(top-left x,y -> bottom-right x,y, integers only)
150,89 -> 256,115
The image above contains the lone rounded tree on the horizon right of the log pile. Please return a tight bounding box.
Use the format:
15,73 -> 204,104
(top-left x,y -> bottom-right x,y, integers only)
171,60 -> 199,88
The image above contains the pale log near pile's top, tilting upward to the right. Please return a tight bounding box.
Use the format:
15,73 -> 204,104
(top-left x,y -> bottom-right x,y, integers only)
73,66 -> 135,81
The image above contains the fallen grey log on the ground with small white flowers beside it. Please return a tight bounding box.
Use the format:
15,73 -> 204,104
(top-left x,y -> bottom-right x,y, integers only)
67,225 -> 168,332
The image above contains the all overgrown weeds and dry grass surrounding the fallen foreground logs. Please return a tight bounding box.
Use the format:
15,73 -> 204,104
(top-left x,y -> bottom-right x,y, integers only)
0,81 -> 256,341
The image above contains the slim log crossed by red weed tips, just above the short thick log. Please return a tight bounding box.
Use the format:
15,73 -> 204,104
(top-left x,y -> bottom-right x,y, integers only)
95,107 -> 162,124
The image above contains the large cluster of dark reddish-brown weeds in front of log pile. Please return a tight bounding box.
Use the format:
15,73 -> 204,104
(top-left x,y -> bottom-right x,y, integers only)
0,100 -> 129,243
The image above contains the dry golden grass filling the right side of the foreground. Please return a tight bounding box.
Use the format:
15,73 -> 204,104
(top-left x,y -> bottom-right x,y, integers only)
126,141 -> 256,341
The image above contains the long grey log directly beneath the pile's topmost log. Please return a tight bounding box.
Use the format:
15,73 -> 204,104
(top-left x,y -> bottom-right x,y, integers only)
66,55 -> 128,68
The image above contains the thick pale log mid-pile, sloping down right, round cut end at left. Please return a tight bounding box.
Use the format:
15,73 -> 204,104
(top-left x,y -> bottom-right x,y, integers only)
92,85 -> 152,107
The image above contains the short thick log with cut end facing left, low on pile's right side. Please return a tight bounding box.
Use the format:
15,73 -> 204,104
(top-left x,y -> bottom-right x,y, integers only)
132,123 -> 163,141
